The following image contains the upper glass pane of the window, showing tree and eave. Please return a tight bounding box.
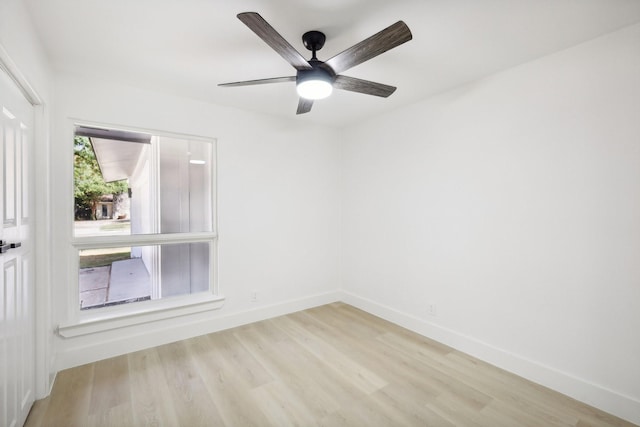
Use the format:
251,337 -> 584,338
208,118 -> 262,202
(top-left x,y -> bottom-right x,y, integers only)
74,127 -> 213,236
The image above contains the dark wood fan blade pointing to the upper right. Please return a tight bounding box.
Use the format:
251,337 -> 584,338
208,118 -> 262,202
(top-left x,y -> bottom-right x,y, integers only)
325,21 -> 412,74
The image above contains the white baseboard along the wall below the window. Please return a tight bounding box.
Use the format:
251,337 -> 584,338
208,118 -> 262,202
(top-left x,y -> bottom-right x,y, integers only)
55,291 -> 341,372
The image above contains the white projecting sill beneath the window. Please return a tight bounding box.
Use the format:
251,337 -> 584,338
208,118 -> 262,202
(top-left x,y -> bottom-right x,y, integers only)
58,295 -> 225,338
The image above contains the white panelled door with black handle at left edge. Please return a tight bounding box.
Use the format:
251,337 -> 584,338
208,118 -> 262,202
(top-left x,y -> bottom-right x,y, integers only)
0,68 -> 35,427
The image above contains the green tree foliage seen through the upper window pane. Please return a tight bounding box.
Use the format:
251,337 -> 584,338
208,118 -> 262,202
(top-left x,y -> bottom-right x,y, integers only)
73,136 -> 127,219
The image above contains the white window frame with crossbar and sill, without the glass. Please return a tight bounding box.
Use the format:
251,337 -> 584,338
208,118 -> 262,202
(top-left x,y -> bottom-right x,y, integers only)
58,120 -> 224,338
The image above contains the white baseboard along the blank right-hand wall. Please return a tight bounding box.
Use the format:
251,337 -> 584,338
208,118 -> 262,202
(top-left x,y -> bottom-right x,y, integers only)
341,292 -> 640,425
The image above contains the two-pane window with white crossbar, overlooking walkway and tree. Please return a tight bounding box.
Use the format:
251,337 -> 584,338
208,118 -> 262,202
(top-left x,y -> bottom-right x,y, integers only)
73,125 -> 217,328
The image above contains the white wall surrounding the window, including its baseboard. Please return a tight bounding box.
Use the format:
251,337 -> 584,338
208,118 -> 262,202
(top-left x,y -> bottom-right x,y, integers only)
51,75 -> 339,369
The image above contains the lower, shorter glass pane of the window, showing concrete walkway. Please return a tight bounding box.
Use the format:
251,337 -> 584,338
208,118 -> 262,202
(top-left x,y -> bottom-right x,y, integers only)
78,242 -> 210,310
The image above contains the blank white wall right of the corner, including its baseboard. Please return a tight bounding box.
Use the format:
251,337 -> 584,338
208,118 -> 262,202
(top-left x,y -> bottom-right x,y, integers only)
342,25 -> 640,423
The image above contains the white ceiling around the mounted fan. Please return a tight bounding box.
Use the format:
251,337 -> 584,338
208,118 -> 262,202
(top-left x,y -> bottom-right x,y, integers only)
25,0 -> 640,127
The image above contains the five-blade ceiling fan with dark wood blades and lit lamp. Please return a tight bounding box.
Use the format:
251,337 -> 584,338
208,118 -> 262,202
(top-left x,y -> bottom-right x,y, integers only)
218,12 -> 412,114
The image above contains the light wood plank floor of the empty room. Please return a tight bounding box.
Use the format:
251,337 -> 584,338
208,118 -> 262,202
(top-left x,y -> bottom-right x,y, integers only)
26,303 -> 632,427
